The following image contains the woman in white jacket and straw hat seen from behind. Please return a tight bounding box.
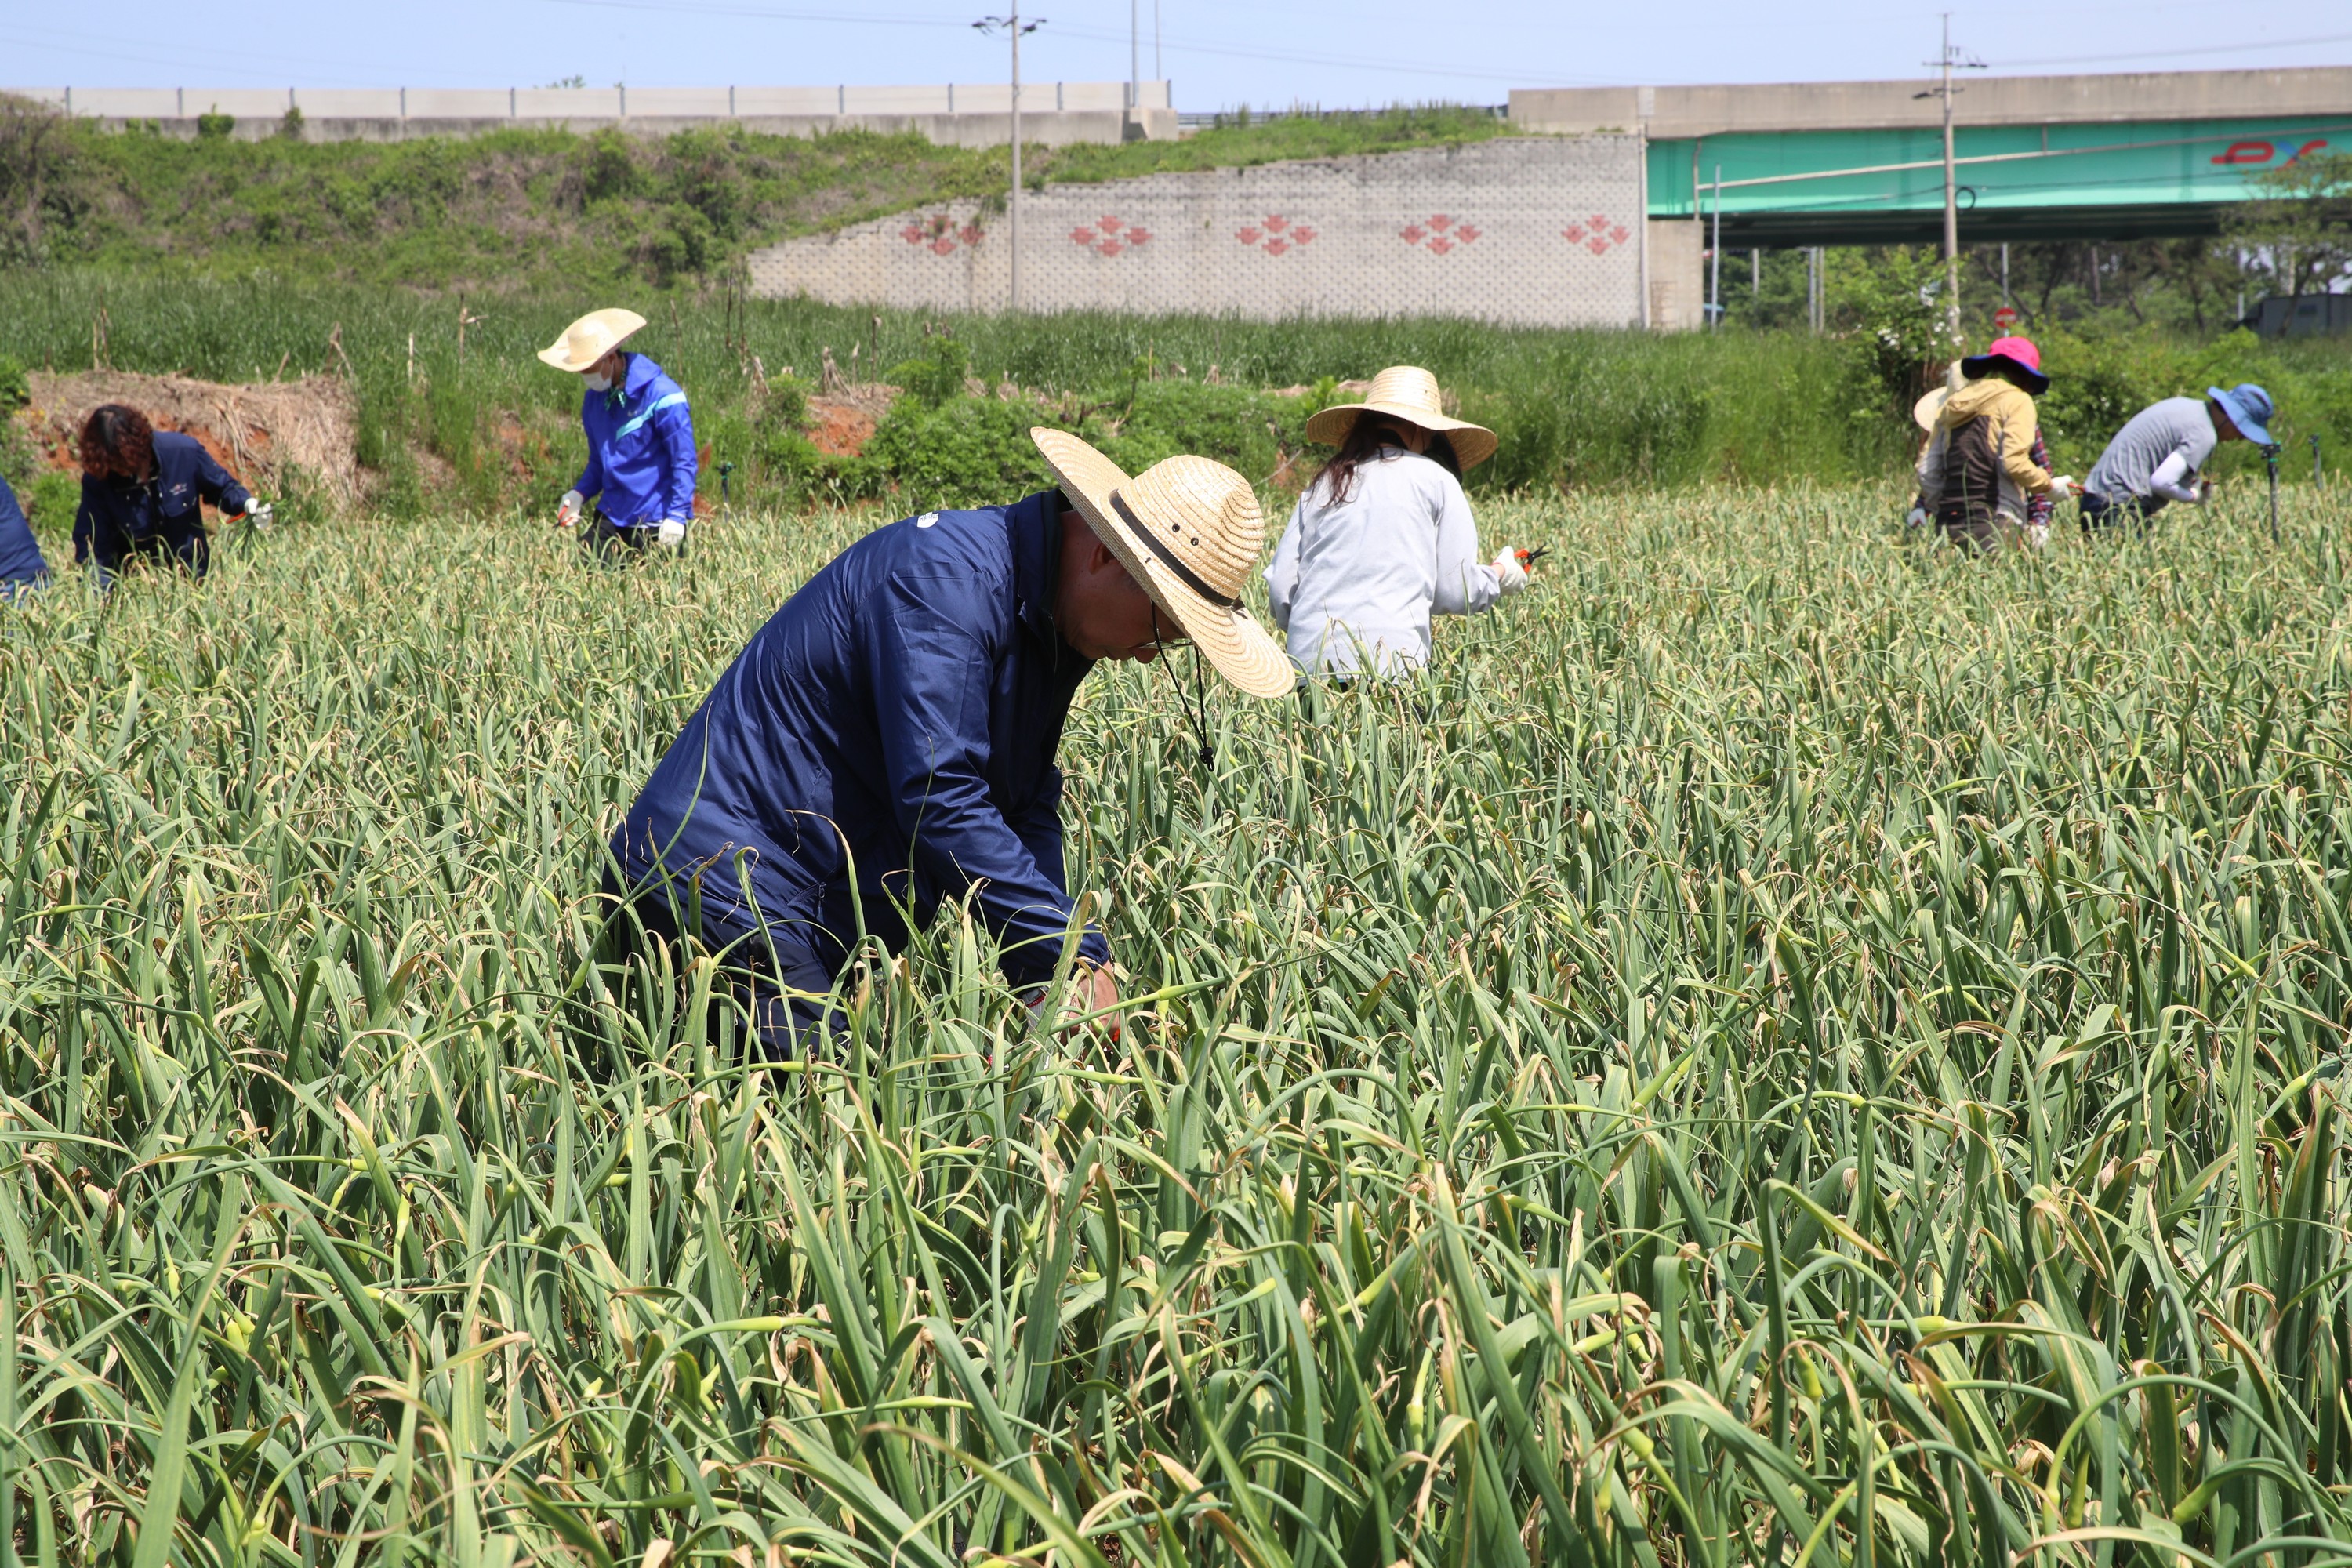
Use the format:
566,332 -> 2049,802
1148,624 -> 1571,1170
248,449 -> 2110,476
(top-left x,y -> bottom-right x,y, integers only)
1265,365 -> 1526,680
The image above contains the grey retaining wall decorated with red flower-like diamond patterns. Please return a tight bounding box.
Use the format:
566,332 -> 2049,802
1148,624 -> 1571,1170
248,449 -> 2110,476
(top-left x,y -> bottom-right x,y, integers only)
750,136 -> 1646,327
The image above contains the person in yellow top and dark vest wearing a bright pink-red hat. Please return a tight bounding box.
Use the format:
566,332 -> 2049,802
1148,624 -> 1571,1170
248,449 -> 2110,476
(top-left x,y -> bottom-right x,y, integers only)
1919,339 -> 2072,550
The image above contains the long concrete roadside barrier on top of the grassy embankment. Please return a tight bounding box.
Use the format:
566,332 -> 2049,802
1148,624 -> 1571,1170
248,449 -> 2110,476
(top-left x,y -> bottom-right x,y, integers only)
0,82 -> 1176,146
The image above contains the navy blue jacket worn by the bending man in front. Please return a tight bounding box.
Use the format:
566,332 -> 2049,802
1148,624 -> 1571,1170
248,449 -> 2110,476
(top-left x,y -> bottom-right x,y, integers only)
612,492 -> 1110,985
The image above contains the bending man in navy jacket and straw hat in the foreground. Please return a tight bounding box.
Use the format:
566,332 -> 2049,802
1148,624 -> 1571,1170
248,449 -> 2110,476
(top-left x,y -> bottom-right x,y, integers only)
607,430 -> 1294,1055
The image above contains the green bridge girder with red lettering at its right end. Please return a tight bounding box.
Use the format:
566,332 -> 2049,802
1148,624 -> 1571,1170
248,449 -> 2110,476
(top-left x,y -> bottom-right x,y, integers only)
1649,111 -> 2352,249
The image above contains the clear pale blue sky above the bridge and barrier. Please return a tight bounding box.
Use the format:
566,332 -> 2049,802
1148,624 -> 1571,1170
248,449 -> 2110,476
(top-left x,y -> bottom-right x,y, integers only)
0,0 -> 2352,108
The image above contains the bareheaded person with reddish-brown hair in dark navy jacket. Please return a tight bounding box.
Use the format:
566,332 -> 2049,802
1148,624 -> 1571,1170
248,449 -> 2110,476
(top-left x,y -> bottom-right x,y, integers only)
73,402 -> 270,588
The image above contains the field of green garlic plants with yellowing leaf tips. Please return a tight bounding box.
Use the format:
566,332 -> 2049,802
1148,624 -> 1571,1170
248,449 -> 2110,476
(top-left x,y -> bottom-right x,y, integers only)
0,489 -> 2352,1568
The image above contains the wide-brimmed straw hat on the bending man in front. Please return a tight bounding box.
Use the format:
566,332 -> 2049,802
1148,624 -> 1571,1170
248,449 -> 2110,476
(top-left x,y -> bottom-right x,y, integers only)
1030,428 -> 1298,696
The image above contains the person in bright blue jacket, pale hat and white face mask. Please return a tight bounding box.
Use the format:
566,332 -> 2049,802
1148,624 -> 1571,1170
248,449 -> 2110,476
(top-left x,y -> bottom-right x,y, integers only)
539,310 -> 696,555
